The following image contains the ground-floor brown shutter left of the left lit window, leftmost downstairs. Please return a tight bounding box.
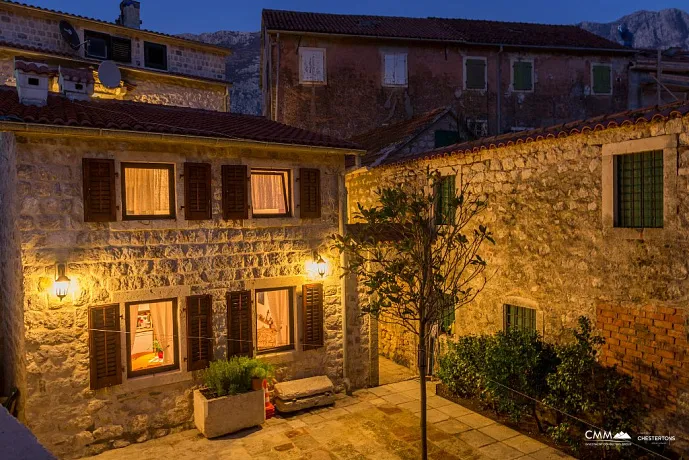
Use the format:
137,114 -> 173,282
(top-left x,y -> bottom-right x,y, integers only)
89,305 -> 122,390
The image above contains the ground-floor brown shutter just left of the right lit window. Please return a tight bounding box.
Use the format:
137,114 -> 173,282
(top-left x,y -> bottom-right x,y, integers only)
227,291 -> 254,357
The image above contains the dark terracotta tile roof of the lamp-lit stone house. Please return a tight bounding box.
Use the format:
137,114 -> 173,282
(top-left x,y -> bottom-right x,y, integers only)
0,86 -> 358,150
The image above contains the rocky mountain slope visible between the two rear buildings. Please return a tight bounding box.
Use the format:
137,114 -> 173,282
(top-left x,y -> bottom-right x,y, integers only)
181,30 -> 261,115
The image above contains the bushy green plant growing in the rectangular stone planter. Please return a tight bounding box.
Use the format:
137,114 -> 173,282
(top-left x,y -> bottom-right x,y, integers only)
203,357 -> 273,396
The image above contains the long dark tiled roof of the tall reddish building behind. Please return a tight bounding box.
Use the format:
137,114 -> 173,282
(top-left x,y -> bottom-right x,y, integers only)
263,10 -> 630,52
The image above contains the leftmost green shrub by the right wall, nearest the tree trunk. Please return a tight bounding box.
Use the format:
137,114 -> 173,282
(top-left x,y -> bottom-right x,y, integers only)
436,335 -> 492,398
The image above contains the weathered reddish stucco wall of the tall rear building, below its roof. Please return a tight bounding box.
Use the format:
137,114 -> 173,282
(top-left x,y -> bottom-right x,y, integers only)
263,33 -> 629,138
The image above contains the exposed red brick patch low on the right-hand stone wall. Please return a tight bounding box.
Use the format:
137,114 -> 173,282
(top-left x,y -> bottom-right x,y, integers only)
596,302 -> 689,451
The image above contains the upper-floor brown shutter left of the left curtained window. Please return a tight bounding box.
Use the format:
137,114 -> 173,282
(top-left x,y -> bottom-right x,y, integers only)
82,158 -> 117,222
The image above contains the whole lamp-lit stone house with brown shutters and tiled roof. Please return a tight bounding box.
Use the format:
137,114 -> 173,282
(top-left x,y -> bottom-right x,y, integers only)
0,87 -> 368,457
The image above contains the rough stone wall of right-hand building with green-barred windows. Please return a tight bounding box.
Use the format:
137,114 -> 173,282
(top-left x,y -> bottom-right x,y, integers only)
347,117 -> 689,446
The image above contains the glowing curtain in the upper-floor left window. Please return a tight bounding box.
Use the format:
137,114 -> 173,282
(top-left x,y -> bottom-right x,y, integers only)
125,168 -> 170,216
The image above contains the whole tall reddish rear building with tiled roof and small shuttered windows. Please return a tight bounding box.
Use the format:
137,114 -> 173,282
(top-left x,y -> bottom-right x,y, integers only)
261,10 -> 635,138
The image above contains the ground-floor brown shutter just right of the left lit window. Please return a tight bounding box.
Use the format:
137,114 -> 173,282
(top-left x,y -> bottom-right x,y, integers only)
187,295 -> 213,371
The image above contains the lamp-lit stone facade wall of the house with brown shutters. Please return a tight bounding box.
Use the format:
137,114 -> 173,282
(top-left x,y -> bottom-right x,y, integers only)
17,132 -> 344,457
